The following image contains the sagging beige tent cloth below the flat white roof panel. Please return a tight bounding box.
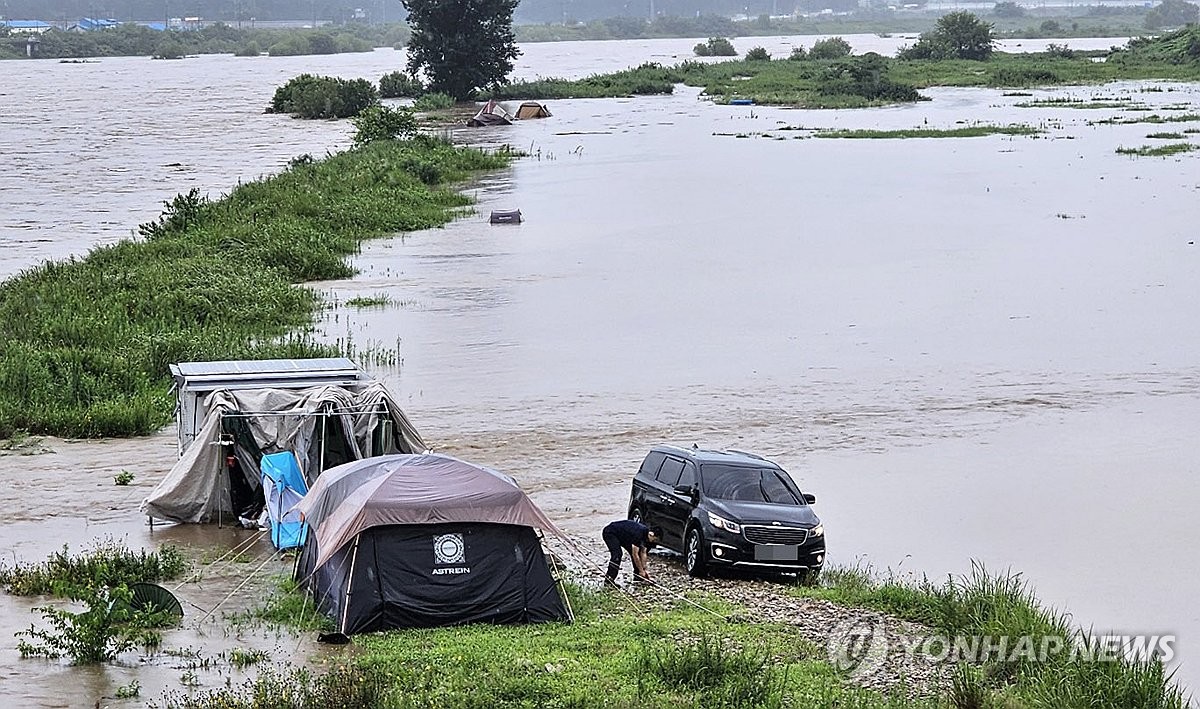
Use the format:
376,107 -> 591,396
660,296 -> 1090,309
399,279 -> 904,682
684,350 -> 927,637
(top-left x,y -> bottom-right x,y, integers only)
142,381 -> 427,523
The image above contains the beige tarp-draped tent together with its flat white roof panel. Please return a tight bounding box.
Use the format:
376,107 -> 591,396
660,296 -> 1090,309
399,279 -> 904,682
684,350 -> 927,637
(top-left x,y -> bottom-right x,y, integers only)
142,360 -> 427,523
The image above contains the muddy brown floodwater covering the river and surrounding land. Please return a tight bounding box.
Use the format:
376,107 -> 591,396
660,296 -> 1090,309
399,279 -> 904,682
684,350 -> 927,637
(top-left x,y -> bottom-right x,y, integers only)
0,36 -> 1200,705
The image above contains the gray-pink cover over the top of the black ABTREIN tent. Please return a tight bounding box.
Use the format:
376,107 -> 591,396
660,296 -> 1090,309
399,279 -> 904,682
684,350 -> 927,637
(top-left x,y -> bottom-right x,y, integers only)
293,453 -> 563,569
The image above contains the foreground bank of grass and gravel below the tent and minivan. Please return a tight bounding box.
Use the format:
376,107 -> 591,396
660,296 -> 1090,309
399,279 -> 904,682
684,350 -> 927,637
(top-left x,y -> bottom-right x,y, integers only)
167,570 -> 1186,709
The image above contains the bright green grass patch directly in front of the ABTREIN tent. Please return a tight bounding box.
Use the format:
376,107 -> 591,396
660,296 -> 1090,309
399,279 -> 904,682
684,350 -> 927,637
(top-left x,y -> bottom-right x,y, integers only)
174,584 -> 942,709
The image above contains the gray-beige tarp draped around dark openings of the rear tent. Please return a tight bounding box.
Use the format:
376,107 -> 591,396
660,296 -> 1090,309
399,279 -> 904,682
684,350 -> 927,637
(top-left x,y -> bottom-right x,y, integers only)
142,383 -> 428,523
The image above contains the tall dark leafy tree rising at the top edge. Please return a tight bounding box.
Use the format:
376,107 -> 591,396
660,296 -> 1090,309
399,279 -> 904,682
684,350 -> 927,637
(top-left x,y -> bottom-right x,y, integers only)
404,0 -> 521,101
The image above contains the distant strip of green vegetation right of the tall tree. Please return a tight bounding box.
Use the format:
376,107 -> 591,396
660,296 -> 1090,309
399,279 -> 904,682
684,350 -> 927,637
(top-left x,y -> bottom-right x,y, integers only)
487,23 -> 1200,108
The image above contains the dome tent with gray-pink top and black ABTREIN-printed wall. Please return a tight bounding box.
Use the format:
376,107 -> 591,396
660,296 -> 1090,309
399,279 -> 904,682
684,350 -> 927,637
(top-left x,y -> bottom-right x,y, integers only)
294,453 -> 569,635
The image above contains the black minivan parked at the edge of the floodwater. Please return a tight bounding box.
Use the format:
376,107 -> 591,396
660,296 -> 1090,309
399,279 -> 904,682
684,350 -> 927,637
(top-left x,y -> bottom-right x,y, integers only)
629,445 -> 826,582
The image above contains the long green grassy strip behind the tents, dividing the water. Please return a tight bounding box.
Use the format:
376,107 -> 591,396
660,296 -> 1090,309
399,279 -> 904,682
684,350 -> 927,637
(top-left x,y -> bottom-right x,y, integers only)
0,138 -> 508,437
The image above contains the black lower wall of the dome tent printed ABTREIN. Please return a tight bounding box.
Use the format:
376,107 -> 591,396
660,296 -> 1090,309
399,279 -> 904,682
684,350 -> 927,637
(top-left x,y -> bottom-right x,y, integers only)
298,523 -> 569,635
